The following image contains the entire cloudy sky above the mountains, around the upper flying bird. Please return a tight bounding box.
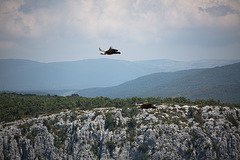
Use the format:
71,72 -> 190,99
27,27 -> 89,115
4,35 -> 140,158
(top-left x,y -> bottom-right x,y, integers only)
0,0 -> 240,62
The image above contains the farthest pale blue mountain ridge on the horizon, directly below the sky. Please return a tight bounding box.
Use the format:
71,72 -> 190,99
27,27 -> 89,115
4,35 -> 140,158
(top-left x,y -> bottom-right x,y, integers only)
0,59 -> 240,93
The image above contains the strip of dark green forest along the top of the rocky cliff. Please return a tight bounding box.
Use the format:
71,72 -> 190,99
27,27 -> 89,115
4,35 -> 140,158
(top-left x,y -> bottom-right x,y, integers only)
0,93 -> 240,122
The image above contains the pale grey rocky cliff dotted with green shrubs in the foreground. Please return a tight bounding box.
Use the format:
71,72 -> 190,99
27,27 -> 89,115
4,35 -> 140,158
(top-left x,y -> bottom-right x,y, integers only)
0,105 -> 240,160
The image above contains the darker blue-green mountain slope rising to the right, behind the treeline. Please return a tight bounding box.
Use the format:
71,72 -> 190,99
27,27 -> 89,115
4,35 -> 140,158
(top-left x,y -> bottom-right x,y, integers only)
77,63 -> 240,103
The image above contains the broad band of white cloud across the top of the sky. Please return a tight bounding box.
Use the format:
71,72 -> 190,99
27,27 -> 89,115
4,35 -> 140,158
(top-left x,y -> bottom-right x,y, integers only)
0,0 -> 240,39
